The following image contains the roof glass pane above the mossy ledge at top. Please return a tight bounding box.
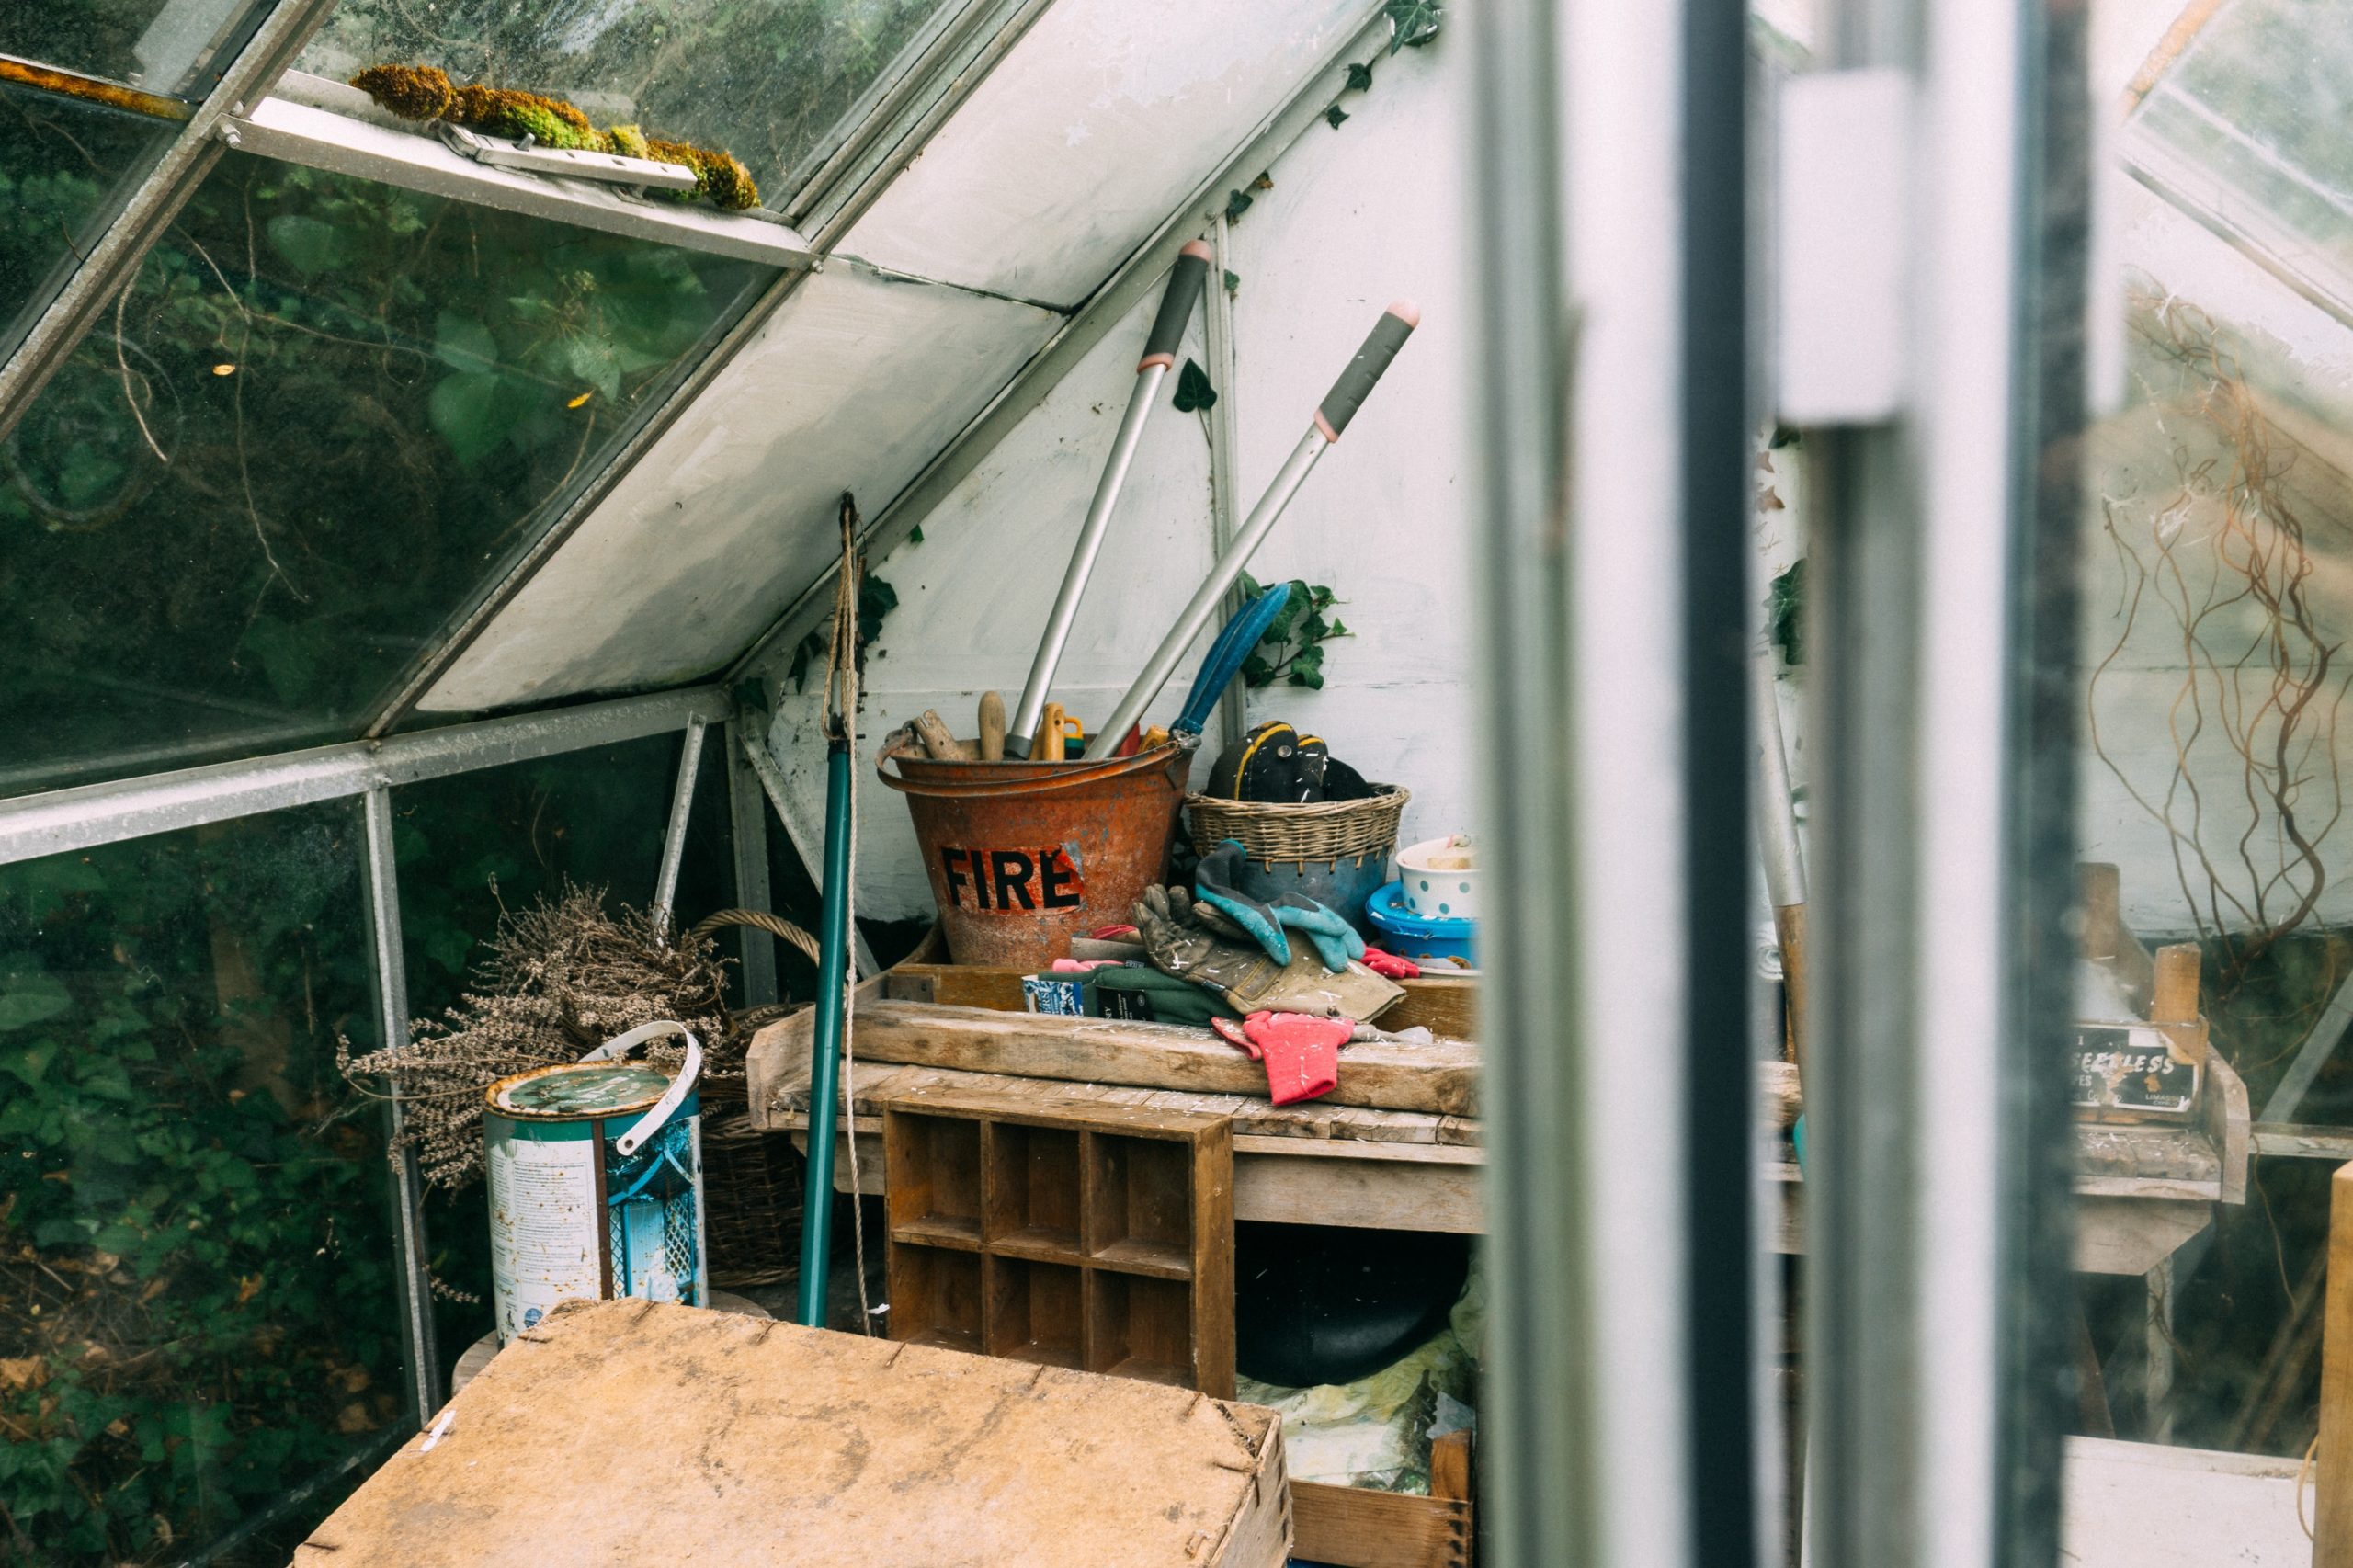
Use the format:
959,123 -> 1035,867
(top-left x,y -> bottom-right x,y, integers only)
297,0 -> 960,205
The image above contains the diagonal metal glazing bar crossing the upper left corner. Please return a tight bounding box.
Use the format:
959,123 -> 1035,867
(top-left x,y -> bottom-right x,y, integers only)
0,0 -> 335,440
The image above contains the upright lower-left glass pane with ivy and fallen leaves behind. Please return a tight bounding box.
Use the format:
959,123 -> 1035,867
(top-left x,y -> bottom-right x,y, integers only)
0,802 -> 415,1565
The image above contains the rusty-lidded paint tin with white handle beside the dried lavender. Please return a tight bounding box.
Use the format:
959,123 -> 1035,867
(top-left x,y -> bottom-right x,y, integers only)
483,1022 -> 709,1345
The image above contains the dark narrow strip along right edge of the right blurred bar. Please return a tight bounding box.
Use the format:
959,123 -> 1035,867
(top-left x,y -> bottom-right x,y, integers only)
1993,0 -> 2089,1568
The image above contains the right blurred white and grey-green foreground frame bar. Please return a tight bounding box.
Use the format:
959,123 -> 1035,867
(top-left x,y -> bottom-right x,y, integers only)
1805,0 -> 2092,1568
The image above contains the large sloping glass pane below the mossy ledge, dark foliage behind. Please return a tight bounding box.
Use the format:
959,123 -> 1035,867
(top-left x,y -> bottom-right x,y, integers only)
0,153 -> 772,791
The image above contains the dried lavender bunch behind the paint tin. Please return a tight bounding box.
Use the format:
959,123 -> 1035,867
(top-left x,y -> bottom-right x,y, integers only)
339,885 -> 748,1189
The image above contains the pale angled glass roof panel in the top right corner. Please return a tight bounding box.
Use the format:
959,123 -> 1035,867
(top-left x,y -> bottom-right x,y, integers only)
2125,0 -> 2353,313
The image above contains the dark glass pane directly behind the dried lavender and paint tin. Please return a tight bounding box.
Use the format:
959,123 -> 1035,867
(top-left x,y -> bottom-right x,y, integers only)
393,733 -> 732,1368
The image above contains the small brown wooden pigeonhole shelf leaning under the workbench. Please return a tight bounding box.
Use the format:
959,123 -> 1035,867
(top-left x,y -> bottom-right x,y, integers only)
880,1095 -> 1233,1399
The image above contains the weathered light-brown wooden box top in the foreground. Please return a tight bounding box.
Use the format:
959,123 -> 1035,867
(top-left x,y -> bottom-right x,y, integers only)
294,1300 -> 1287,1568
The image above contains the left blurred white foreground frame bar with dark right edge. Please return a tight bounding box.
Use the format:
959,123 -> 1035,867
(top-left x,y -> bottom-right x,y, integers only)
1466,0 -> 1769,1568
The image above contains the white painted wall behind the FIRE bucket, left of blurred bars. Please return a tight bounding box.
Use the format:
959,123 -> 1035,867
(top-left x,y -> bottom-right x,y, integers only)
772,24 -> 1475,918
